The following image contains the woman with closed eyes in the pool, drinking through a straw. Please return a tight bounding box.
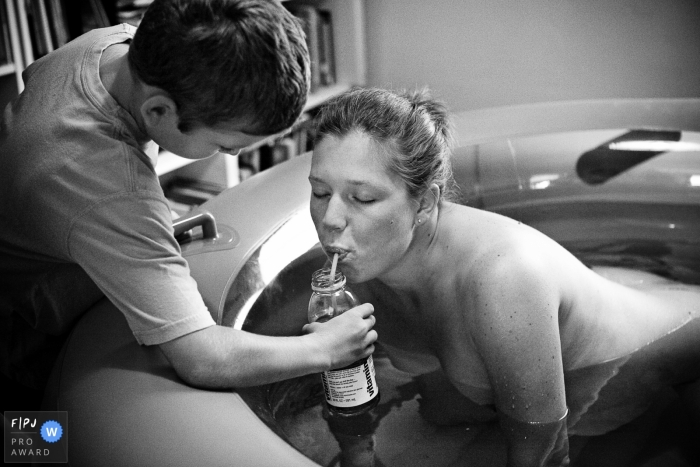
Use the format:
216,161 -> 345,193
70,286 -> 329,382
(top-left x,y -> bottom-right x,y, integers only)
309,89 -> 700,465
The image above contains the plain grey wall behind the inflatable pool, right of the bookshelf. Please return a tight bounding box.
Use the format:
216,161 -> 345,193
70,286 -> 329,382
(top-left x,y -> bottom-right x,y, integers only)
366,0 -> 700,111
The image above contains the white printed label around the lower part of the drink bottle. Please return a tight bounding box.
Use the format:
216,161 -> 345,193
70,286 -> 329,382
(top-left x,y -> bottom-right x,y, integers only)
321,355 -> 379,408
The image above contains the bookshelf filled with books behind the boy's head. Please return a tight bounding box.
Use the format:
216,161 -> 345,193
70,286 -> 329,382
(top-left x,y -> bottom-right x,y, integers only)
0,0 -> 367,214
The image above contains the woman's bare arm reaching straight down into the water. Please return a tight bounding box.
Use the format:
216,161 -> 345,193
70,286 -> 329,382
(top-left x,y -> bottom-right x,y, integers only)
468,249 -> 568,466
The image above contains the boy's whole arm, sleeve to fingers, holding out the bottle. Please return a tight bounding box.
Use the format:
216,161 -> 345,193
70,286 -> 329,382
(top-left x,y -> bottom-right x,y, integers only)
69,193 -> 376,387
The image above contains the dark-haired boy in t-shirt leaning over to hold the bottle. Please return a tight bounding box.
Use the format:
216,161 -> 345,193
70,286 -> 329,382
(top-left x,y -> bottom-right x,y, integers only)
0,0 -> 376,410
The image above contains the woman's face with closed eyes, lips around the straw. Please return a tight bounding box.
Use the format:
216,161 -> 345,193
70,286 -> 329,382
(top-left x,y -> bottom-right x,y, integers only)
309,132 -> 418,282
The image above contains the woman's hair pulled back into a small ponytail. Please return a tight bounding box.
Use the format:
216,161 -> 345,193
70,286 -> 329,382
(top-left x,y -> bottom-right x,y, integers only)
316,88 -> 456,201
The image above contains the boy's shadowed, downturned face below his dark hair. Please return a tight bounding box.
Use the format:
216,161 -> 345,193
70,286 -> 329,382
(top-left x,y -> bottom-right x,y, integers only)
153,119 -> 270,159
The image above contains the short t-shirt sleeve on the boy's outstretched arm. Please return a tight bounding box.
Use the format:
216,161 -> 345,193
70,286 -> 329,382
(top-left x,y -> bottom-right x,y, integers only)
68,192 -> 215,345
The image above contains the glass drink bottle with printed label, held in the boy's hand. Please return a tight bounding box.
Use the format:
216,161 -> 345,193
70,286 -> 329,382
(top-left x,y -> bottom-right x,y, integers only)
308,268 -> 379,416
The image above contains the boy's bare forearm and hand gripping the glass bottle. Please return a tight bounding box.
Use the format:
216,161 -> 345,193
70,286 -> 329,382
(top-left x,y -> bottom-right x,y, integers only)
160,304 -> 377,388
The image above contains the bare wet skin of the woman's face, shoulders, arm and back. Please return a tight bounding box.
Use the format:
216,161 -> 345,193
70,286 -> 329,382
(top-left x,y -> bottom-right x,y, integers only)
310,133 -> 700,464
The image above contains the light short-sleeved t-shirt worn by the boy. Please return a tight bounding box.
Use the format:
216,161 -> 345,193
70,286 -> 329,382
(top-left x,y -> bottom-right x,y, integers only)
0,25 -> 215,388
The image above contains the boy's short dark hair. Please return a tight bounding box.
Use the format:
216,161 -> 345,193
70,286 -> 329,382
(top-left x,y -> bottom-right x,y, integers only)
129,0 -> 310,135
